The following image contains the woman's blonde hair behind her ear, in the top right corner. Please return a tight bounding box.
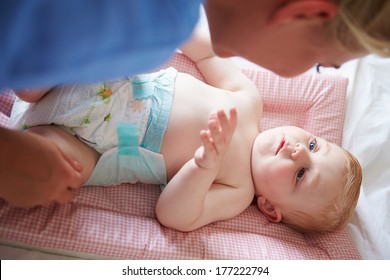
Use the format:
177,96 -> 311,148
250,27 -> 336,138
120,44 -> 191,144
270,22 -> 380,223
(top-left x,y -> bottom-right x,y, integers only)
326,0 -> 390,57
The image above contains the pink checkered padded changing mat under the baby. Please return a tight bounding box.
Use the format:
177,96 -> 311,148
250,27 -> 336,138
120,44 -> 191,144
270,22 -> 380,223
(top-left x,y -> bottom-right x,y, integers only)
0,54 -> 361,259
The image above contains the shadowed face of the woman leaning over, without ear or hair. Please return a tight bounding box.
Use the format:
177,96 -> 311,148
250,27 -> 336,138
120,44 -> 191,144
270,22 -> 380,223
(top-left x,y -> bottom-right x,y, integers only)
205,0 -> 366,77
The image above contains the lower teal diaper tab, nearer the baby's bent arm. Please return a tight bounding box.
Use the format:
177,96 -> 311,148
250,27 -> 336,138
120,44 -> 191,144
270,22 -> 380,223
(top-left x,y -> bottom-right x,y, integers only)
117,123 -> 139,156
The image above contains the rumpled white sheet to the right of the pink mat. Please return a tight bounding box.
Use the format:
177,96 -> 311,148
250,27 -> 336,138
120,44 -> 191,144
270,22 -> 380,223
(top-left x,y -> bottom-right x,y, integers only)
333,55 -> 390,259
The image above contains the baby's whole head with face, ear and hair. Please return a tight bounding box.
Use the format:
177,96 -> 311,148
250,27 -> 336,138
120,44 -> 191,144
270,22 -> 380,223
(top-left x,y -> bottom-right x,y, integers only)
251,126 -> 362,232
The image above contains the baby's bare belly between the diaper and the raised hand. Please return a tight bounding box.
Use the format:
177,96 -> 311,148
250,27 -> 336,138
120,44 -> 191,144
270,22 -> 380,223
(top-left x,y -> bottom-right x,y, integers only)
161,73 -> 233,180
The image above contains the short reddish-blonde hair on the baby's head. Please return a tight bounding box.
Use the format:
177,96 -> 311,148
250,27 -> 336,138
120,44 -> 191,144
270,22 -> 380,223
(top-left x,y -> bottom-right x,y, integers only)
282,149 -> 363,233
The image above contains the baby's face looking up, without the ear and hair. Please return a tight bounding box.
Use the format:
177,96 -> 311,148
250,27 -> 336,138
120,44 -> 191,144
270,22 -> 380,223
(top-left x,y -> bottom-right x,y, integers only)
252,126 -> 347,213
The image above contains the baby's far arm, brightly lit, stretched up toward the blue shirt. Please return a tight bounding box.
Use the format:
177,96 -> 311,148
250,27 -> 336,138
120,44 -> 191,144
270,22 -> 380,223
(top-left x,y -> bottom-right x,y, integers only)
181,29 -> 257,92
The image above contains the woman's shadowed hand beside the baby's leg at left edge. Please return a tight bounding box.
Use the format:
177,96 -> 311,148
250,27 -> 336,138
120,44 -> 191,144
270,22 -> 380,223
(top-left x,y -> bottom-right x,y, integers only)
0,128 -> 83,208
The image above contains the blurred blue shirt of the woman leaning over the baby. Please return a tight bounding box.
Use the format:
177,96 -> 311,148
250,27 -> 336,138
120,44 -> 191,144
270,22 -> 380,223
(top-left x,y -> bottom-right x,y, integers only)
0,0 -> 201,89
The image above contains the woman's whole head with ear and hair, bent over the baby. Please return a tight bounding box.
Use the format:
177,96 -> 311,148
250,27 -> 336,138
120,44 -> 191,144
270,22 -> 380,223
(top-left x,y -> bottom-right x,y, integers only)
205,0 -> 390,76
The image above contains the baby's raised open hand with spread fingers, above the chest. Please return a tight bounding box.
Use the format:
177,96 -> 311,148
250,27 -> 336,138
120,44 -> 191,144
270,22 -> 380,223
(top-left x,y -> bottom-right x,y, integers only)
195,108 -> 237,169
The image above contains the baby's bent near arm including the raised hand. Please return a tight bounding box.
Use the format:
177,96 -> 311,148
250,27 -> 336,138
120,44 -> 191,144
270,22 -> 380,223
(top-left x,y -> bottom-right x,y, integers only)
156,108 -> 248,231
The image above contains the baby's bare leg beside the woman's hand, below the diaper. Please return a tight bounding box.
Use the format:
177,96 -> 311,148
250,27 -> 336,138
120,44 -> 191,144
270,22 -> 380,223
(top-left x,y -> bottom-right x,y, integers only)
27,125 -> 100,183
